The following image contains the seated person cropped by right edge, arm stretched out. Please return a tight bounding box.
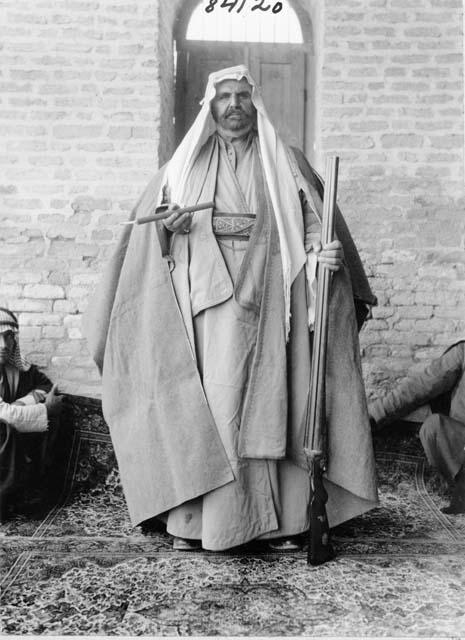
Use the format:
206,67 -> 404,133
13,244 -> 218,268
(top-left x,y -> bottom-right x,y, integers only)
368,340 -> 465,514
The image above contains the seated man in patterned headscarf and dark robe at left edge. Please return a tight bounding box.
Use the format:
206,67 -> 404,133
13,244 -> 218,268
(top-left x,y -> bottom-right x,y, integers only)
0,307 -> 61,520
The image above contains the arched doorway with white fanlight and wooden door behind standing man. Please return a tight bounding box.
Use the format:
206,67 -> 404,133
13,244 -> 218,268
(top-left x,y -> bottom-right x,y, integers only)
175,1 -> 309,149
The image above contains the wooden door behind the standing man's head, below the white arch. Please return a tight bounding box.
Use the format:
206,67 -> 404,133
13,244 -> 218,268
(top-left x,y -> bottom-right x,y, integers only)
175,41 -> 306,149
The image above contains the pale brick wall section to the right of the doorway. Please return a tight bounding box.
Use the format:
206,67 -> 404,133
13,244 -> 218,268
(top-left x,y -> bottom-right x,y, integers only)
320,0 -> 465,391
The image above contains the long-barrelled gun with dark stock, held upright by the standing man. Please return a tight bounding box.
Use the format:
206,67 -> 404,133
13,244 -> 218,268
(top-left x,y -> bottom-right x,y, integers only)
304,156 -> 339,565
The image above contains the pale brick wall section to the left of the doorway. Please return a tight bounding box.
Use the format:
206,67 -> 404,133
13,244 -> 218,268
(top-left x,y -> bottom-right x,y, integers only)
0,0 -> 161,393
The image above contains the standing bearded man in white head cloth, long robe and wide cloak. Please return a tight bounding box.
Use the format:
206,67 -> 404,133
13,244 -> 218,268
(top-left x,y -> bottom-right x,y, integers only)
86,66 -> 377,550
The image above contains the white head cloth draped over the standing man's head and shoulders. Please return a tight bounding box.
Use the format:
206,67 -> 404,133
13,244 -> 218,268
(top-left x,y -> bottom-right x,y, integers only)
163,65 -> 306,335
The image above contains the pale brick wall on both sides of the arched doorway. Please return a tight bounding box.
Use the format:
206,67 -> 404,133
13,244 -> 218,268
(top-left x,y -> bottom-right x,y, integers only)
0,0 -> 465,395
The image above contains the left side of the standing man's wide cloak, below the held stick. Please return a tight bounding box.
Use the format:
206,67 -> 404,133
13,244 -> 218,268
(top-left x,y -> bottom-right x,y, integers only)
83,164 -> 234,525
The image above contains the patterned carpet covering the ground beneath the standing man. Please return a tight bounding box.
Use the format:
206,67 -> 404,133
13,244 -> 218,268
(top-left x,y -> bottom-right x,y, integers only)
0,398 -> 465,637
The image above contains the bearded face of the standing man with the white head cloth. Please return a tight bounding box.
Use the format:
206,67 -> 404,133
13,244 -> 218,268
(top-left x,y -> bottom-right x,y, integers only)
211,78 -> 257,132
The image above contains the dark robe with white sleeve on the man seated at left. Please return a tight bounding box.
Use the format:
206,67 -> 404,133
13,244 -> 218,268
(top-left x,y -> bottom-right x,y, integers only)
0,365 -> 52,508
